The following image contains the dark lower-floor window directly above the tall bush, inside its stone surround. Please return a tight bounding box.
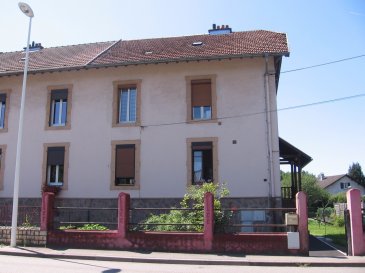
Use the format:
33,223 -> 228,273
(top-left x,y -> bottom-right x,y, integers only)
191,142 -> 213,184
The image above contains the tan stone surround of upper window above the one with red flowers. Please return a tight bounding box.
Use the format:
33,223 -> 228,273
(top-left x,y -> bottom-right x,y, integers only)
45,84 -> 73,130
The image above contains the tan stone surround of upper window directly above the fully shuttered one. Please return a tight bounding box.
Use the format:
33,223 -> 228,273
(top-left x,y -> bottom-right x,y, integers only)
112,79 -> 142,127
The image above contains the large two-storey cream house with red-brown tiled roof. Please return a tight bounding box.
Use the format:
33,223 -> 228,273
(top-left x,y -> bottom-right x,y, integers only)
0,26 -> 310,207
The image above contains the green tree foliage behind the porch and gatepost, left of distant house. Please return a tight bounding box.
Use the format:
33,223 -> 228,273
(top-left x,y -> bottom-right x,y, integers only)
281,171 -> 330,207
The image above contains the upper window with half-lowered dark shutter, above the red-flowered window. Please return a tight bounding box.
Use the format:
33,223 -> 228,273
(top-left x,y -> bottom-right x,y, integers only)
50,90 -> 68,126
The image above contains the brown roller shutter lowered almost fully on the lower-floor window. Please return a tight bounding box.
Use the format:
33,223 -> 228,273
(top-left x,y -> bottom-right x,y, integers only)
115,144 -> 135,178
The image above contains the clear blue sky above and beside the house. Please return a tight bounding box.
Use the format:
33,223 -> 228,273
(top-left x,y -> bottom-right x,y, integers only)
0,0 -> 365,175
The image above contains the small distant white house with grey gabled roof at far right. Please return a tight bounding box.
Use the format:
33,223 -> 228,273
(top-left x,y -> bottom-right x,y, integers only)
318,174 -> 365,195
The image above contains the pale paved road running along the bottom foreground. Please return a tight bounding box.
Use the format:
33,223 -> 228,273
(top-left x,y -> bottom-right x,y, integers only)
0,255 -> 364,273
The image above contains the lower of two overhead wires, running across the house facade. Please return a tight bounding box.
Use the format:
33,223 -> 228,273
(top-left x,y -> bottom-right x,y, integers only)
141,93 -> 365,128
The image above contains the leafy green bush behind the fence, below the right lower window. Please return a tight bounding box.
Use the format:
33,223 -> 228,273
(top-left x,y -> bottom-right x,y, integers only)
141,183 -> 231,232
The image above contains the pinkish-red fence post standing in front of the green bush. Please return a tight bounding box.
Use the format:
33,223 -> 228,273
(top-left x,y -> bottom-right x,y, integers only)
204,192 -> 214,250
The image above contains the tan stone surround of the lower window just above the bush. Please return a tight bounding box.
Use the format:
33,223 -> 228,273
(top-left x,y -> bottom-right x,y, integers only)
186,137 -> 219,187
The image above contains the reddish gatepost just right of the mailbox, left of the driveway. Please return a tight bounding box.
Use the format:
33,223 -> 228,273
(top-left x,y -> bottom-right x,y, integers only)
295,191 -> 309,255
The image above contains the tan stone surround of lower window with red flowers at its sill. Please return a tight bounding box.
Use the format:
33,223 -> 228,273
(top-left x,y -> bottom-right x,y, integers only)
41,142 -> 70,190
